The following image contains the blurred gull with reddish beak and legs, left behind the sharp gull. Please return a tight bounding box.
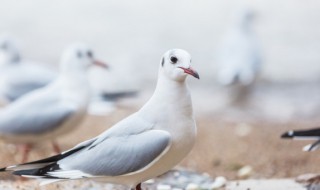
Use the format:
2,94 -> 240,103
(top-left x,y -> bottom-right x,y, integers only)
0,44 -> 106,163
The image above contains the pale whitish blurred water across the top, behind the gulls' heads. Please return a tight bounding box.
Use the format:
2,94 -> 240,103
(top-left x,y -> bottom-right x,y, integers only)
0,0 -> 320,81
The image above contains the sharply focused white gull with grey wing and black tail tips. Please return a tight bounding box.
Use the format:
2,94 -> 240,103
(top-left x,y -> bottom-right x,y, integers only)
0,49 -> 199,190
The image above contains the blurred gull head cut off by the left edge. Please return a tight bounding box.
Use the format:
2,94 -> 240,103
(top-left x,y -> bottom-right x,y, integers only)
0,35 -> 20,65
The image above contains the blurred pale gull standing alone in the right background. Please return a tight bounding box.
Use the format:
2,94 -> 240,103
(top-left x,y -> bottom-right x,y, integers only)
217,9 -> 261,86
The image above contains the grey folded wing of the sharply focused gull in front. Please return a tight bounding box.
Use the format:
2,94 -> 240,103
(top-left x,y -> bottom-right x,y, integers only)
58,130 -> 171,178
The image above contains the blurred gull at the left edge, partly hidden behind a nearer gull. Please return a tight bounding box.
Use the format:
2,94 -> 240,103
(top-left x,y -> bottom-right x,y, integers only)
0,36 -> 57,103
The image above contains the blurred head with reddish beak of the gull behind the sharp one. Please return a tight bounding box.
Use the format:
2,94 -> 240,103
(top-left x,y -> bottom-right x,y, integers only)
61,43 -> 108,72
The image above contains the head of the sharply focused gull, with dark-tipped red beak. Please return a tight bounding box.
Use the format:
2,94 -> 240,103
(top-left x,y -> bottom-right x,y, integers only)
160,49 -> 200,81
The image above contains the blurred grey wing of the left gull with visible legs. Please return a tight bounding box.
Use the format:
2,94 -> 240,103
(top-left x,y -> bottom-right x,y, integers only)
0,94 -> 76,135
